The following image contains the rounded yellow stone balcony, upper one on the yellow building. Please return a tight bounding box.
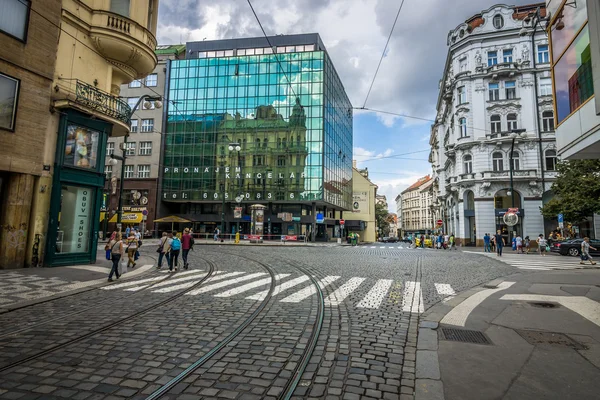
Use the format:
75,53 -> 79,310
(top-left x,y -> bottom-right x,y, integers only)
90,10 -> 157,83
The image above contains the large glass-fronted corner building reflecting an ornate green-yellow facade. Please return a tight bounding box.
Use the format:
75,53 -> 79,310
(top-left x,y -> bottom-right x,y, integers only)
160,34 -> 352,240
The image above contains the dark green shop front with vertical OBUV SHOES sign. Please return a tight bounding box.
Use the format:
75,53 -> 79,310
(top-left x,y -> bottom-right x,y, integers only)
45,110 -> 112,266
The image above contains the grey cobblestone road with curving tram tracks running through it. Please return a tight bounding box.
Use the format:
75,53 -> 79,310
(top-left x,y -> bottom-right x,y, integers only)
0,246 -> 516,399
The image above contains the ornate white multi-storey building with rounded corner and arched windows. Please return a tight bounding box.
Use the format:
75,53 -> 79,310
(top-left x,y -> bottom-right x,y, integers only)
429,3 -> 557,245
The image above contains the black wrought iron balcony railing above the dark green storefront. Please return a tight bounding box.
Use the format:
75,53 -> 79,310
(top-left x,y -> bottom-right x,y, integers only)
75,80 -> 131,125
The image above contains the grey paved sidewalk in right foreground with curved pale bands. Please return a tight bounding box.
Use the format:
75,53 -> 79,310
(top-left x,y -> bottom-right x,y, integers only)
415,270 -> 600,400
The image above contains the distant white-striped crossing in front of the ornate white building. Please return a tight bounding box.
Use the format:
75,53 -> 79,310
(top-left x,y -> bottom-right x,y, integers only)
464,249 -> 584,271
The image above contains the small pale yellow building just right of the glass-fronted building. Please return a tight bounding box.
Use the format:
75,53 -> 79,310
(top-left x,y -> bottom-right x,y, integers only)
345,161 -> 377,243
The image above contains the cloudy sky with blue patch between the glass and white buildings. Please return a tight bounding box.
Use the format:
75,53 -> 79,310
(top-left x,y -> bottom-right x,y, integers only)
157,0 -> 534,212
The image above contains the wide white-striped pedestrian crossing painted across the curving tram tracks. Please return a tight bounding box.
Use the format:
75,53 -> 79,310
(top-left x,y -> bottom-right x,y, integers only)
101,270 -> 456,313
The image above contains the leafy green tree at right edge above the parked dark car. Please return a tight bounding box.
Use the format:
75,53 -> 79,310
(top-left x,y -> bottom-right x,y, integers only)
540,160 -> 600,224
